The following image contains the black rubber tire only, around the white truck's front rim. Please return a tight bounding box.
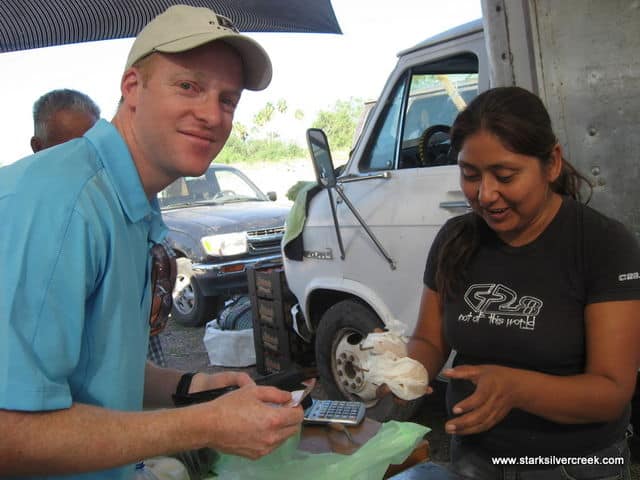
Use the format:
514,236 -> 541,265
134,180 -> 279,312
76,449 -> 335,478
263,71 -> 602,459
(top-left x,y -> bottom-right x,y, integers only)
315,299 -> 421,422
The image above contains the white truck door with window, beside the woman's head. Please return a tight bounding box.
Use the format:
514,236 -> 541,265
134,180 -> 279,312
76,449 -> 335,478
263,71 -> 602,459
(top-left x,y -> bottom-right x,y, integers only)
337,43 -> 484,333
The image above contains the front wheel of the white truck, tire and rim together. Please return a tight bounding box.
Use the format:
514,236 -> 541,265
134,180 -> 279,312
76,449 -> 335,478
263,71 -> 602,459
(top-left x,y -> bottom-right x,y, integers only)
315,300 -> 421,422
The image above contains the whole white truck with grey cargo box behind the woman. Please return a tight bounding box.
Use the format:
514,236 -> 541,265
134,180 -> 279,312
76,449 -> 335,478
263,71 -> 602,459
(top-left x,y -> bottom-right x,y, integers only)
283,0 -> 640,417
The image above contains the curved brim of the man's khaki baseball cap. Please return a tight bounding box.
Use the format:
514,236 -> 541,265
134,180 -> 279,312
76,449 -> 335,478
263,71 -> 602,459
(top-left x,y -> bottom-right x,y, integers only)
154,33 -> 272,90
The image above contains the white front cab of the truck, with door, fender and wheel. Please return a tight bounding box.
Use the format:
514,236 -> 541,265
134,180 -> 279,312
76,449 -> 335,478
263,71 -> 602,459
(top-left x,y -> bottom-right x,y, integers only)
283,20 -> 489,416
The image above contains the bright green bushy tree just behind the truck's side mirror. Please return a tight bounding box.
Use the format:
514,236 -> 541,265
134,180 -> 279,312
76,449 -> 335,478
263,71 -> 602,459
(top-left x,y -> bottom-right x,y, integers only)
312,97 -> 364,150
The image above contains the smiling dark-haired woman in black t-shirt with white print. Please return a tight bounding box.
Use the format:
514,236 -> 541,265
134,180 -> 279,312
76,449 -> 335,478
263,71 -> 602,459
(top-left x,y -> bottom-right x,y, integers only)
409,87 -> 640,480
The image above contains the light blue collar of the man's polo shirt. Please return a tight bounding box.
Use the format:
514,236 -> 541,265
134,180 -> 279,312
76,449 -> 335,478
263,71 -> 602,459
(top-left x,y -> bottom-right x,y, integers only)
84,119 -> 166,242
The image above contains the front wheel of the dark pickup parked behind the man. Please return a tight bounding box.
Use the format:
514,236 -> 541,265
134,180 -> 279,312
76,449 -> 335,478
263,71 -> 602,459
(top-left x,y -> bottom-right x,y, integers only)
171,257 -> 220,327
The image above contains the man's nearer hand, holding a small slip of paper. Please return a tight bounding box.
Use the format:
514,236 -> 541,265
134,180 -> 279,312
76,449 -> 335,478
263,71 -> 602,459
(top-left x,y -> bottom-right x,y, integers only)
197,380 -> 303,459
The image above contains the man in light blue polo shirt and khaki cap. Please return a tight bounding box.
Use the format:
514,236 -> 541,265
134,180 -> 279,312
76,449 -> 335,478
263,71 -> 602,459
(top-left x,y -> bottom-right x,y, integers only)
0,5 -> 302,479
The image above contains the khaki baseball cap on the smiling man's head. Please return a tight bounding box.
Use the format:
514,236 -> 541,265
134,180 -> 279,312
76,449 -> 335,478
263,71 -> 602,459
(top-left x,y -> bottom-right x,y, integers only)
125,5 -> 272,90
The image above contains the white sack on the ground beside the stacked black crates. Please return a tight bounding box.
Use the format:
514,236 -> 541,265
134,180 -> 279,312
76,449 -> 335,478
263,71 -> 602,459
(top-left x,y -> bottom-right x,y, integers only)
204,320 -> 256,367
